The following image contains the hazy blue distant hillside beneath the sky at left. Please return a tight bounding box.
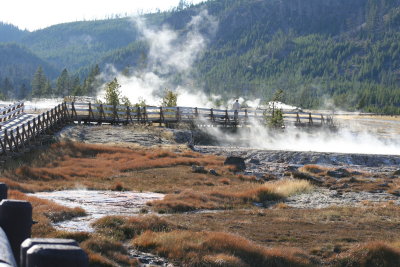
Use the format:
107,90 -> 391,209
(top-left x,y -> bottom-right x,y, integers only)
22,19 -> 142,71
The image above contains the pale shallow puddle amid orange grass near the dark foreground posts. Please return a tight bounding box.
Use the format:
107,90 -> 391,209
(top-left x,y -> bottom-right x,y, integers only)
31,190 -> 165,232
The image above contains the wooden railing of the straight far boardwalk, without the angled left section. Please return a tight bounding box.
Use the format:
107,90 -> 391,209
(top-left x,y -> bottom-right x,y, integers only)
67,102 -> 333,126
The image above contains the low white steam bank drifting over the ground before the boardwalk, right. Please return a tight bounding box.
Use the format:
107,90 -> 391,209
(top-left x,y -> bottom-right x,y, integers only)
200,119 -> 400,155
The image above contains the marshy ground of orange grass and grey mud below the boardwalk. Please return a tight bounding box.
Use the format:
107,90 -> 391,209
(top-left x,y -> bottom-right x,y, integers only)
0,120 -> 400,266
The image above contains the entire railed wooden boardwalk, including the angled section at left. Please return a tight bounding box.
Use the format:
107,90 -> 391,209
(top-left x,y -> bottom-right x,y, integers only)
0,102 -> 334,154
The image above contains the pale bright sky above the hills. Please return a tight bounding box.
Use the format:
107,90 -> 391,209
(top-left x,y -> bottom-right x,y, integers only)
0,0 -> 205,31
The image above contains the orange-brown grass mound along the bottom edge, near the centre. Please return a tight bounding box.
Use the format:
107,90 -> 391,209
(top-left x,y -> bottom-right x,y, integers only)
132,231 -> 310,266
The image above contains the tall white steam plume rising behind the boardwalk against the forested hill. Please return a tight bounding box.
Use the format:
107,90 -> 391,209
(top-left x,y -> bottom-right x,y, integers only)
98,10 -> 219,107
